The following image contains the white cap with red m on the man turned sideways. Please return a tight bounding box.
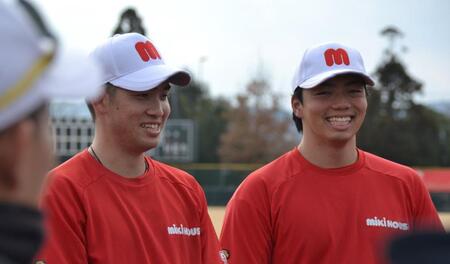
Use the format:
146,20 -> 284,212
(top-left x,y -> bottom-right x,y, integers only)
91,33 -> 191,91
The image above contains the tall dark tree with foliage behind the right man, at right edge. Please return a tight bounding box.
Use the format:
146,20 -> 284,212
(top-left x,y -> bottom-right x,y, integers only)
358,27 -> 450,166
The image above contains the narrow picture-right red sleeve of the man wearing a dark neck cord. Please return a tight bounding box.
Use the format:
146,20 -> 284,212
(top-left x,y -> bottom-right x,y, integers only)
197,184 -> 224,264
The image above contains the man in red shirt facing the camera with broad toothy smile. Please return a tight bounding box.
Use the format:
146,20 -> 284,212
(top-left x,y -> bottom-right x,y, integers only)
221,43 -> 443,264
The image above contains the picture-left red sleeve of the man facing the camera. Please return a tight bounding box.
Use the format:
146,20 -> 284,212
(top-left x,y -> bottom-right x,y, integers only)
220,178 -> 272,264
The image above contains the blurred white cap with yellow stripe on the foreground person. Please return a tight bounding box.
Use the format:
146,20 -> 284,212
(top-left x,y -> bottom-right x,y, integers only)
0,0 -> 101,130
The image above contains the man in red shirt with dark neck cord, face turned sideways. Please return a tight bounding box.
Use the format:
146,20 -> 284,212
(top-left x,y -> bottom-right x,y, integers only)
37,33 -> 227,264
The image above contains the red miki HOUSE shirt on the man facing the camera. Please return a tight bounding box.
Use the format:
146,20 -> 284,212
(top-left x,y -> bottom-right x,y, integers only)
221,149 -> 444,264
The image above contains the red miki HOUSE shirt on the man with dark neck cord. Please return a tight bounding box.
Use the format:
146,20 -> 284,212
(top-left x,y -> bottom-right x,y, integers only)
36,150 -> 223,264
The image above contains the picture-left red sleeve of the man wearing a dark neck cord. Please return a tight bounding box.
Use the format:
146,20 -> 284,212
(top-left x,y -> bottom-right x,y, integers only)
36,172 -> 88,264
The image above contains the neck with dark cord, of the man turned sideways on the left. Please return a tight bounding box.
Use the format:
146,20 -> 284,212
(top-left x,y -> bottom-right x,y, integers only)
89,138 -> 147,178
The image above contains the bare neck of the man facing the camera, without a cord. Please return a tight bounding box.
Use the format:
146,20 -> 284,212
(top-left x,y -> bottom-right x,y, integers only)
297,135 -> 358,168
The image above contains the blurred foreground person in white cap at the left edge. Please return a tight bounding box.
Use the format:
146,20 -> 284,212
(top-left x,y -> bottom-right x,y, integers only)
0,0 -> 100,264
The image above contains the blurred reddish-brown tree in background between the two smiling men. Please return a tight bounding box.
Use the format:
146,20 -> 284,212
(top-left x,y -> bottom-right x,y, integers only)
219,78 -> 296,163
